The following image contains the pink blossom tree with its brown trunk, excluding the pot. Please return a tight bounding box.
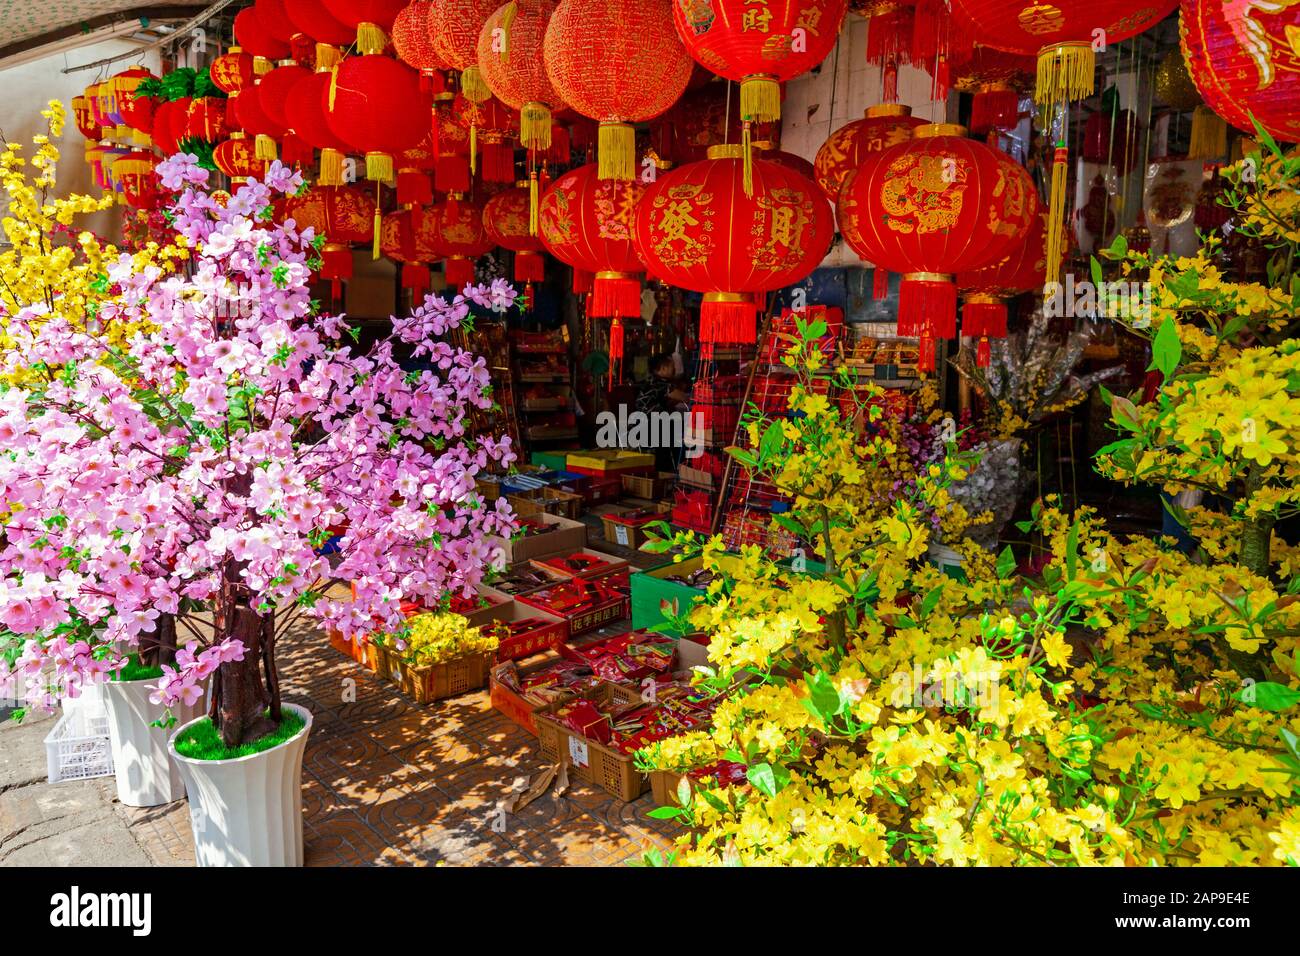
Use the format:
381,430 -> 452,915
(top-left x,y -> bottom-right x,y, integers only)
0,155 -> 515,745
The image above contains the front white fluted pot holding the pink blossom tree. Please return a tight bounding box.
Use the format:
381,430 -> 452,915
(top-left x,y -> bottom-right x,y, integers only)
168,704 -> 312,866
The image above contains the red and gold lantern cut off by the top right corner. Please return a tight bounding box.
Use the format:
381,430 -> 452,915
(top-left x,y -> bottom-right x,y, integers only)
1179,0 -> 1300,145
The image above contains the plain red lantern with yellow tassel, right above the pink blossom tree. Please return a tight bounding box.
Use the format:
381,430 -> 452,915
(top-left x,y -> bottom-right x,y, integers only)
325,55 -> 430,182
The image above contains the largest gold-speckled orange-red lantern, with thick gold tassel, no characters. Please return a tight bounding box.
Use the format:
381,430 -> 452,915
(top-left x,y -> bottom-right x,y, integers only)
543,0 -> 693,179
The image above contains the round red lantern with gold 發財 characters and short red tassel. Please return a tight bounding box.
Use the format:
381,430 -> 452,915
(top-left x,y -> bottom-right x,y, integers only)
636,144 -> 835,352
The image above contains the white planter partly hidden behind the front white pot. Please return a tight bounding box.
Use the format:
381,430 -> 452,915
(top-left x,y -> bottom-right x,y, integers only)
103,679 -> 203,806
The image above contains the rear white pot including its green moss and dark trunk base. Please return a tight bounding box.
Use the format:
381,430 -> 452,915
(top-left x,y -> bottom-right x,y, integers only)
103,615 -> 202,806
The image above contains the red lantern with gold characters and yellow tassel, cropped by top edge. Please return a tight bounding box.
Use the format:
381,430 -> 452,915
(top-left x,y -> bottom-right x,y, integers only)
672,0 -> 845,167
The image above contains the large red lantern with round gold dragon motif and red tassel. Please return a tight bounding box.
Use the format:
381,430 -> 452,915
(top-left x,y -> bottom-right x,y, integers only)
837,130 -> 1039,371
